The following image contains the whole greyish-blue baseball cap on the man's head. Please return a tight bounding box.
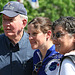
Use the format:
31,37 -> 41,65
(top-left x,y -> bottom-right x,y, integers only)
0,1 -> 27,17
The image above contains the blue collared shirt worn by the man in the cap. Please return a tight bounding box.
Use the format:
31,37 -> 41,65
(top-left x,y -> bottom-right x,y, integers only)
0,32 -> 33,75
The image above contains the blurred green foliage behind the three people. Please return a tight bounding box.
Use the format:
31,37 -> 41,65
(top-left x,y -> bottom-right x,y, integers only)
0,0 -> 75,34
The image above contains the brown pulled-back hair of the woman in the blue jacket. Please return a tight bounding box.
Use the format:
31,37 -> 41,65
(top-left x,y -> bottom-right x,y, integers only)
28,17 -> 52,33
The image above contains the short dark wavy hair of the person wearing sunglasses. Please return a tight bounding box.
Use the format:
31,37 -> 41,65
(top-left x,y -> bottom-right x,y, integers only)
52,16 -> 75,34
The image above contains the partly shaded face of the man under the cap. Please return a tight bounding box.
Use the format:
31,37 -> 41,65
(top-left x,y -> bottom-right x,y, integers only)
2,15 -> 23,39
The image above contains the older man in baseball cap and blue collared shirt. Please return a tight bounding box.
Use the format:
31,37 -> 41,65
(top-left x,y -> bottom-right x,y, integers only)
0,1 -> 33,75
